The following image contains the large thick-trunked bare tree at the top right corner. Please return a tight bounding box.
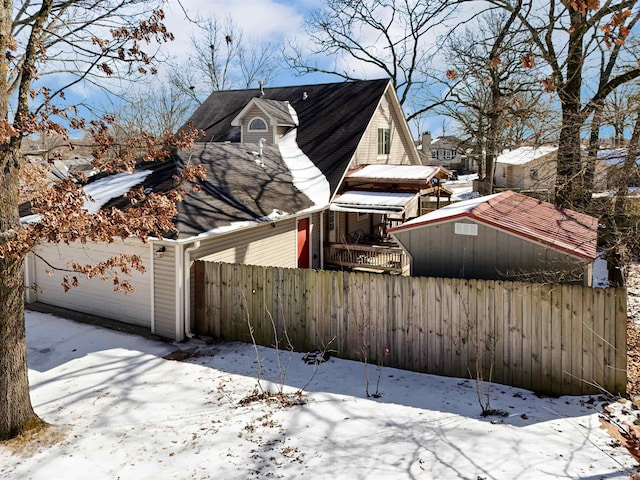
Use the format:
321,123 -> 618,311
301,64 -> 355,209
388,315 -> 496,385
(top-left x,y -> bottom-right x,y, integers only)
489,0 -> 640,210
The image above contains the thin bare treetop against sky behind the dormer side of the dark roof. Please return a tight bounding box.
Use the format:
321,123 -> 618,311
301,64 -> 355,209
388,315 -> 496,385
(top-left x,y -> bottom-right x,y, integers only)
170,16 -> 280,104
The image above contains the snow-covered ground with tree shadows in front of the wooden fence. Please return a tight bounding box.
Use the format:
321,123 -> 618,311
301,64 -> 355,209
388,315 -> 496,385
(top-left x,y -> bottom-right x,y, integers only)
0,312 -> 635,480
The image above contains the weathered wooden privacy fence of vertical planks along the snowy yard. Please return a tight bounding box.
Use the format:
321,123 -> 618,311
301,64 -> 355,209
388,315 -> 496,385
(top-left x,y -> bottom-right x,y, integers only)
194,262 -> 627,395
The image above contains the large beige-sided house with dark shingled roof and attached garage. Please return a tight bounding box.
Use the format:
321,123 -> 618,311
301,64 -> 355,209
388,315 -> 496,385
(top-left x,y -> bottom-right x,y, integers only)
25,80 -> 424,340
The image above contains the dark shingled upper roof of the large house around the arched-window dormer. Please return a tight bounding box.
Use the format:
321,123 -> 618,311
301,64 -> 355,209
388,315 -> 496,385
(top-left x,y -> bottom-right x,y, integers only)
182,79 -> 389,195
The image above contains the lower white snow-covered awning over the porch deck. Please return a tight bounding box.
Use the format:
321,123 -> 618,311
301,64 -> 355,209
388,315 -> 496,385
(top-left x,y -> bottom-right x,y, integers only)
329,190 -> 419,218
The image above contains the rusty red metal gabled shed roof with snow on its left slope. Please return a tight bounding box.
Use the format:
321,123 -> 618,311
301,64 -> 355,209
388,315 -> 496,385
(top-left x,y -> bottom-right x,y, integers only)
388,191 -> 598,260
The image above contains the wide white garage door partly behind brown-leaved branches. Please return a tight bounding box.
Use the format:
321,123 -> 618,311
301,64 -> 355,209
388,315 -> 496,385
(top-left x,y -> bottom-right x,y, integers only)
32,242 -> 152,327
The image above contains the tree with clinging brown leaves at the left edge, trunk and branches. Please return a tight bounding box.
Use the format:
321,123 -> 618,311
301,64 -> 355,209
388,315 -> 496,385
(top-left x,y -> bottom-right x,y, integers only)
0,0 -> 201,440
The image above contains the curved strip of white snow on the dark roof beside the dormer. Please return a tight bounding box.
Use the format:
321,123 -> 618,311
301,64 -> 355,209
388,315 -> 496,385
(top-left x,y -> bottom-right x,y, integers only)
278,114 -> 330,207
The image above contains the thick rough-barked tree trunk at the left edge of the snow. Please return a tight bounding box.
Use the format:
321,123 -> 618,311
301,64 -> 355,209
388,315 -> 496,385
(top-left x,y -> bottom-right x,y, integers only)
0,144 -> 43,440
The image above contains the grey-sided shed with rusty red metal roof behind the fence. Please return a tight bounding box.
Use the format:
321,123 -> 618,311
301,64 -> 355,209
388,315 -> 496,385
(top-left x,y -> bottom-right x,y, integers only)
389,191 -> 598,285
